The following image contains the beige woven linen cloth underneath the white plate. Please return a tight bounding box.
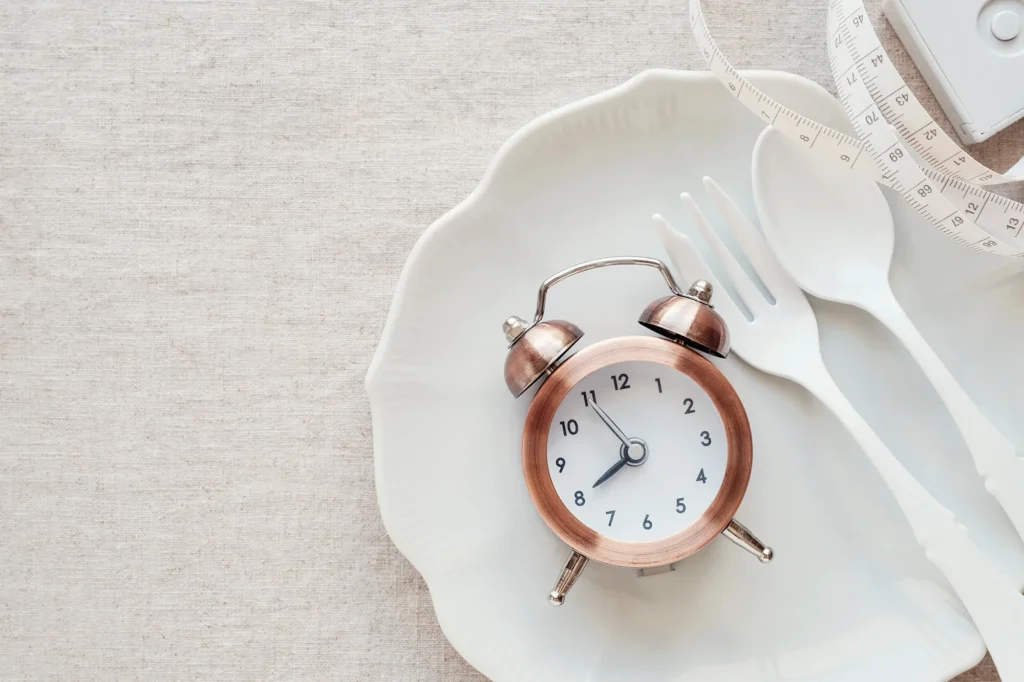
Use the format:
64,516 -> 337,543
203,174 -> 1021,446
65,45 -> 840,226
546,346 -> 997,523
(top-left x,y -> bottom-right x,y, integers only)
0,0 -> 1024,682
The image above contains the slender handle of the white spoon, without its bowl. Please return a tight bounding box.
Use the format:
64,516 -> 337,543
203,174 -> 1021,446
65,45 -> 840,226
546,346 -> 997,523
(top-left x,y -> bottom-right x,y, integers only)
869,292 -> 1024,538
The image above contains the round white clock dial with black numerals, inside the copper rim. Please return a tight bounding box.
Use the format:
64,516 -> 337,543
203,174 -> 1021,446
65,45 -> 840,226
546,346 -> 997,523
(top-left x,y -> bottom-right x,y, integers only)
547,361 -> 728,543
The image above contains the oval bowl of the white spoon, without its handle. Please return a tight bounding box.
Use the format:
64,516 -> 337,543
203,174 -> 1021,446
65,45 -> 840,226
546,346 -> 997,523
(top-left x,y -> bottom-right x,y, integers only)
754,127 -> 895,304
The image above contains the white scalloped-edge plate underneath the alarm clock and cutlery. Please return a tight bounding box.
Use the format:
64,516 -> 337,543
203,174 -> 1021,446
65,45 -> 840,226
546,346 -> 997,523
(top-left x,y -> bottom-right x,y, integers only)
367,72 -> 1024,682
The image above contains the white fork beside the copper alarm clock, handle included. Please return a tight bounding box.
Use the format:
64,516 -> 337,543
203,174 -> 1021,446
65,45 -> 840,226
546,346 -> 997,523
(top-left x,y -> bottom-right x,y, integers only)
654,178 -> 1024,682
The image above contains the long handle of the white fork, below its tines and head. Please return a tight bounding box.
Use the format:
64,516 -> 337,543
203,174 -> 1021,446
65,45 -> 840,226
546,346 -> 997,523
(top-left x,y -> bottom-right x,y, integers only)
802,361 -> 1024,682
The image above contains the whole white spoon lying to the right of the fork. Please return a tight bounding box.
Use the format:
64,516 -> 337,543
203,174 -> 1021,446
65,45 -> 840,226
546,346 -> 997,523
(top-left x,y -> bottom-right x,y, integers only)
754,127 -> 1024,538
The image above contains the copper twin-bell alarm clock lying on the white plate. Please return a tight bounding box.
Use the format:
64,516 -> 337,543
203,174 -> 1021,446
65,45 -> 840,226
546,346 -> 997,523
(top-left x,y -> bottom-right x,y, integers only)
503,257 -> 774,606
